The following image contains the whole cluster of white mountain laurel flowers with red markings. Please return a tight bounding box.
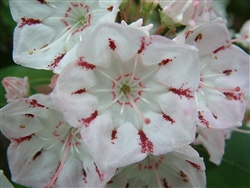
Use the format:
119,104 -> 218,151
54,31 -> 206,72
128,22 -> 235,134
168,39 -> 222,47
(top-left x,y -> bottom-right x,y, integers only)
0,0 -> 249,188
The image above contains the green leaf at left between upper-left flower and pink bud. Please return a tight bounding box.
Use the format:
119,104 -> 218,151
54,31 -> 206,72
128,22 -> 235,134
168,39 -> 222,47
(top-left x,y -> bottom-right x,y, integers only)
0,65 -> 53,107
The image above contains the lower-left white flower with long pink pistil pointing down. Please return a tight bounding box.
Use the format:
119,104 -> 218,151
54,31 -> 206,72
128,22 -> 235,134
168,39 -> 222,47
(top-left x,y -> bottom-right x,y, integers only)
0,94 -> 115,188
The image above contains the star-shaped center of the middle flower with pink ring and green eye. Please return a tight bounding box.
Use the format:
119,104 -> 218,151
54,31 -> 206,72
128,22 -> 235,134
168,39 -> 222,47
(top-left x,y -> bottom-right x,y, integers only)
89,54 -> 167,130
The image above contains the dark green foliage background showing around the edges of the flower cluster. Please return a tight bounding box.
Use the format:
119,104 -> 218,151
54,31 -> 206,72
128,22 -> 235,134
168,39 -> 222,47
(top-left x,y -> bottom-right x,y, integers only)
0,0 -> 250,188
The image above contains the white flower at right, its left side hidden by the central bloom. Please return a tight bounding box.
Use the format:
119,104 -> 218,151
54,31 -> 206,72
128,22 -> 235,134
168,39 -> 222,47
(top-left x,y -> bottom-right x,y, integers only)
179,19 -> 250,129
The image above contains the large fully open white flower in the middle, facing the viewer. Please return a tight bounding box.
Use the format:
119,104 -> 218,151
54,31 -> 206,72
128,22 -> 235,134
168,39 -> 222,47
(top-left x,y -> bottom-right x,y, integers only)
52,23 -> 199,172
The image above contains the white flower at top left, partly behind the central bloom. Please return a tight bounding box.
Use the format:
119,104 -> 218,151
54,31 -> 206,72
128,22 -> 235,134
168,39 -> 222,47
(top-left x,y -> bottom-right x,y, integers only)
10,0 -> 120,73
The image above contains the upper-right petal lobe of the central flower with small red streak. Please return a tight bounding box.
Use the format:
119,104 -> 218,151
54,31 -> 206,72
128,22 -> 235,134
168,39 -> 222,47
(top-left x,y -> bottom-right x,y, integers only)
142,36 -> 199,90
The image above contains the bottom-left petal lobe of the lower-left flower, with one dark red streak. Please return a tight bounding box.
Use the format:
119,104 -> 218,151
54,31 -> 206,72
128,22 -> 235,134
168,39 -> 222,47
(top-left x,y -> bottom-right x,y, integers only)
8,136 -> 60,187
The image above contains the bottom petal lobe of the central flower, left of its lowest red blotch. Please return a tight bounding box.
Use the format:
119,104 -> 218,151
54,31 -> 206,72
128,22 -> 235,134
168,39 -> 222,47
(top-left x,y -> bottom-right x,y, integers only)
81,116 -> 147,170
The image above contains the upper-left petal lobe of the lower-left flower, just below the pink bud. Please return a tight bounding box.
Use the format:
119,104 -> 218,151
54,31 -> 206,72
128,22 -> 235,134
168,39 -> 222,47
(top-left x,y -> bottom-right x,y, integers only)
0,95 -> 48,139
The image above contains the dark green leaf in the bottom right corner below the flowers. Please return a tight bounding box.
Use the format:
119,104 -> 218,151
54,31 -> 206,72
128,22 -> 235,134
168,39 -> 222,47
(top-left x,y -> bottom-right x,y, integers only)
193,126 -> 250,188
